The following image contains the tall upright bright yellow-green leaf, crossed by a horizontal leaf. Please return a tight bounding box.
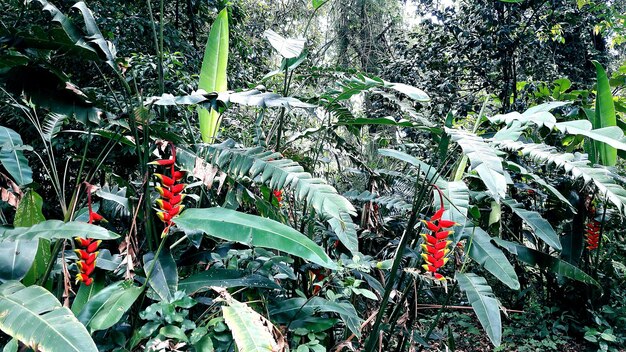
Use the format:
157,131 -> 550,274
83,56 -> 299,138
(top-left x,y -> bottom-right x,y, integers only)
198,8 -> 228,143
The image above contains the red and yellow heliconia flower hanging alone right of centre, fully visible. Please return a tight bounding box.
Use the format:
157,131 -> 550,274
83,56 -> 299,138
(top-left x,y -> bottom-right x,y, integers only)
421,186 -> 457,280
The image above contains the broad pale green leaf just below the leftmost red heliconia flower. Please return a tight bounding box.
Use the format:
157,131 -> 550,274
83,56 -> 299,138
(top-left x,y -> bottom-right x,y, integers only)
78,281 -> 143,331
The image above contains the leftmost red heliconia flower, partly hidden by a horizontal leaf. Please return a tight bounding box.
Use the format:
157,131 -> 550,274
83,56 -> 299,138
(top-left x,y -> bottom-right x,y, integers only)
75,182 -> 106,286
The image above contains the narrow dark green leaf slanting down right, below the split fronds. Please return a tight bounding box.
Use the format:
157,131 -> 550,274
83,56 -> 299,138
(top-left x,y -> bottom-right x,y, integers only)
494,238 -> 601,288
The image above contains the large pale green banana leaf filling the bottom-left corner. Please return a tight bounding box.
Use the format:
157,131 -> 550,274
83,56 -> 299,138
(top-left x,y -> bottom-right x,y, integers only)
0,281 -> 98,352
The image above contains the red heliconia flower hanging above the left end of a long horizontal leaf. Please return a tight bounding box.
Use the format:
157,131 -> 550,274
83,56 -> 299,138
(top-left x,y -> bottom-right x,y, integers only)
149,142 -> 186,236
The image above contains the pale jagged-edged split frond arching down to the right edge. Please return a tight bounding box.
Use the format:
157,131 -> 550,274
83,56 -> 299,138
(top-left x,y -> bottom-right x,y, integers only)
496,141 -> 626,213
